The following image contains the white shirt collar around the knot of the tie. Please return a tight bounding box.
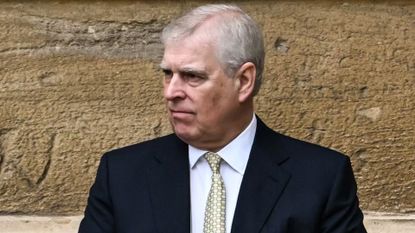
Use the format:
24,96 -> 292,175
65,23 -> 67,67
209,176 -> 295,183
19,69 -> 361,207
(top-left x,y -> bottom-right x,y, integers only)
189,115 -> 257,175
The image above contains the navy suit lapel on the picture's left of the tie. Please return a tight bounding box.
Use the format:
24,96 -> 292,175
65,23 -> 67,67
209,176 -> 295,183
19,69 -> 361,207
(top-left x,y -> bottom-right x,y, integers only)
148,136 -> 190,232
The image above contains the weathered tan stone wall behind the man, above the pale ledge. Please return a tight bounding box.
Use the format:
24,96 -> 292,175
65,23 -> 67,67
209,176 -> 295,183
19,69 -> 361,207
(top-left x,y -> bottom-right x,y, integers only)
0,0 -> 415,214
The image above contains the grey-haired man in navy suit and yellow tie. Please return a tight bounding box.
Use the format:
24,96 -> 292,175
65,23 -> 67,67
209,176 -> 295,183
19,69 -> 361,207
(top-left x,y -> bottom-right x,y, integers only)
79,5 -> 366,233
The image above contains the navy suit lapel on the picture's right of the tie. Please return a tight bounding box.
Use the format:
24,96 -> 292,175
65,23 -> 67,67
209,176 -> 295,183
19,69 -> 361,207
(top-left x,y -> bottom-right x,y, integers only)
232,120 -> 290,233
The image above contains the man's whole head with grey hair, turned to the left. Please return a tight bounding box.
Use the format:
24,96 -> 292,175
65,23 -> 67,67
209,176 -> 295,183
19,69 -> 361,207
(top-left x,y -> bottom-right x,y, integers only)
160,5 -> 264,151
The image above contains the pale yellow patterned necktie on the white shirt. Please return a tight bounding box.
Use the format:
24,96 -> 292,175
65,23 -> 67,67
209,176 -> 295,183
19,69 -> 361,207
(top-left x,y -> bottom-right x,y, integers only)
203,152 -> 226,233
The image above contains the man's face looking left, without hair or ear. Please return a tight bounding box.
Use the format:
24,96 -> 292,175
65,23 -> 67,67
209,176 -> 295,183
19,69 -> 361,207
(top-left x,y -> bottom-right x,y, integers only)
161,33 -> 244,150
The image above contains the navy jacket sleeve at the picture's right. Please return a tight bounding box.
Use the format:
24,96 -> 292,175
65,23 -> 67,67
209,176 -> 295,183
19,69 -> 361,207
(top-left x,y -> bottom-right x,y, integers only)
320,158 -> 366,233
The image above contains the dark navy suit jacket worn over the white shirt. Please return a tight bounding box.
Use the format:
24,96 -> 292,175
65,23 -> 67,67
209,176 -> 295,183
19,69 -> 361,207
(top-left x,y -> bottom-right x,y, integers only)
79,120 -> 366,233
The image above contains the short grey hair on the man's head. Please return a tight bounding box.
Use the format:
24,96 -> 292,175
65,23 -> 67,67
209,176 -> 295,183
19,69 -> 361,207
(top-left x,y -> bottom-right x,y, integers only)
161,4 -> 265,95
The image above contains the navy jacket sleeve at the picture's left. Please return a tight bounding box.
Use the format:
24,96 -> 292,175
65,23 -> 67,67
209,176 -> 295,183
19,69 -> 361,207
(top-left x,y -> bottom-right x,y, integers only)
78,154 -> 115,233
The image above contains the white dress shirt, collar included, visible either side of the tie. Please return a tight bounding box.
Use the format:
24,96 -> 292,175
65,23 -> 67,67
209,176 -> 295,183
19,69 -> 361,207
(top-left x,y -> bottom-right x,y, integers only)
189,115 -> 257,233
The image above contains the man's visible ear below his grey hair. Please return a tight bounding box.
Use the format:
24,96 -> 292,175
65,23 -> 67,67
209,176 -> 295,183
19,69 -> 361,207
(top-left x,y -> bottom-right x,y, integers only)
236,62 -> 256,102
